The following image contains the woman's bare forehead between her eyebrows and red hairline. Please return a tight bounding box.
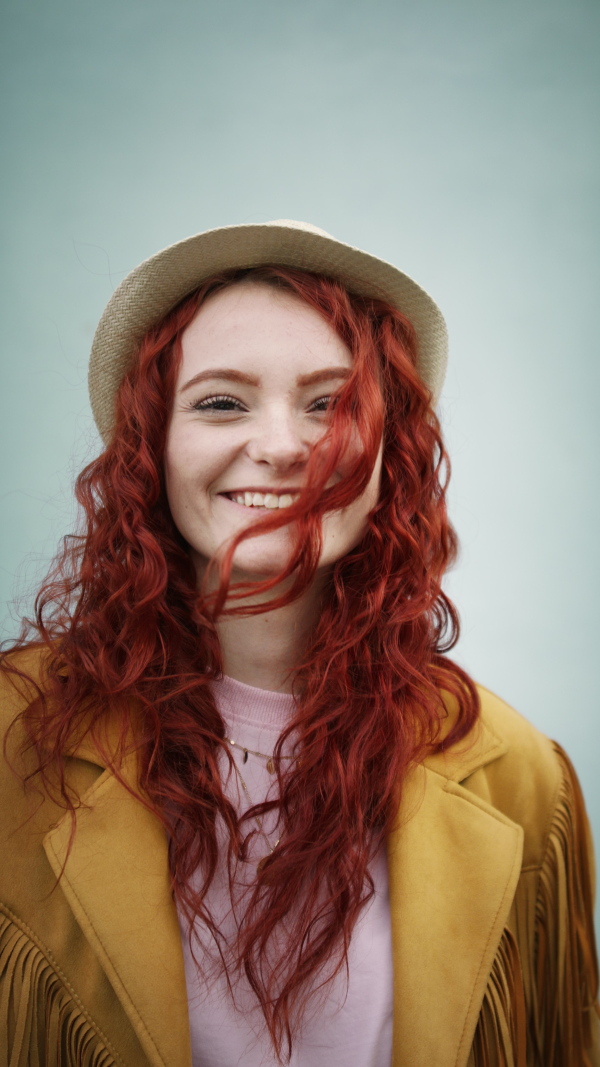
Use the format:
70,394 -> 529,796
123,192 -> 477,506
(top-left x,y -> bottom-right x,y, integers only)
177,283 -> 352,373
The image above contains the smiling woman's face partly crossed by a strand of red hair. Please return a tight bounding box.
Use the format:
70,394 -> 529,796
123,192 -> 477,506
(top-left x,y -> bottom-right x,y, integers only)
164,283 -> 381,580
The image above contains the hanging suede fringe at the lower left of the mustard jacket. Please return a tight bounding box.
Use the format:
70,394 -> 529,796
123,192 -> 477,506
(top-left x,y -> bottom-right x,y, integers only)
0,908 -> 121,1067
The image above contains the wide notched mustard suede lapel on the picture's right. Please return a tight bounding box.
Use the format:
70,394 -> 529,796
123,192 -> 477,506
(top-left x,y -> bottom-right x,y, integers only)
388,722 -> 523,1067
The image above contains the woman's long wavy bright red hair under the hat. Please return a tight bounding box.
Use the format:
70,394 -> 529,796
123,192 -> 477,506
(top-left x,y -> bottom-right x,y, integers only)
3,267 -> 478,1060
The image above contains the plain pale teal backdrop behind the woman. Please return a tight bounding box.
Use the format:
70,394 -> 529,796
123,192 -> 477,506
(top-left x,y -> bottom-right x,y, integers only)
0,0 -> 600,913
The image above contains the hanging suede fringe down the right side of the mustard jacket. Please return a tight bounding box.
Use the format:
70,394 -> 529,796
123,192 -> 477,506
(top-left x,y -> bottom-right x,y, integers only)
469,743 -> 600,1067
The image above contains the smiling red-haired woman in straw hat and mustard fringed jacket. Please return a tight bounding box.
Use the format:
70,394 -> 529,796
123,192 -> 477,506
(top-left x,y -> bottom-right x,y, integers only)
0,221 -> 600,1067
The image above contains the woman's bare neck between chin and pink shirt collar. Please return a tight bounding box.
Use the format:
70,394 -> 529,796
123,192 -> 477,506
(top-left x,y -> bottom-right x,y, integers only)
217,582 -> 321,692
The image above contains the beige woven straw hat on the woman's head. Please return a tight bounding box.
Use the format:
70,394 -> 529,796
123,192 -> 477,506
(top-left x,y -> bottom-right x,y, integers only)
89,219 -> 447,444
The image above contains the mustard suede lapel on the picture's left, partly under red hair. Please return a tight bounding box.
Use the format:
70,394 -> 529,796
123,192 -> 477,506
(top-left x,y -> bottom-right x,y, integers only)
44,753 -> 191,1067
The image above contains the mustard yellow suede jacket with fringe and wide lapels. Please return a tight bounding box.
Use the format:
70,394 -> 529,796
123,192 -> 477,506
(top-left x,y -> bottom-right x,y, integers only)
0,657 -> 600,1067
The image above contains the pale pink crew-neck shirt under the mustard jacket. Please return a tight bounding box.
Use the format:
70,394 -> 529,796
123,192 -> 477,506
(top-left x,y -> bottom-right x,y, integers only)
180,678 -> 393,1067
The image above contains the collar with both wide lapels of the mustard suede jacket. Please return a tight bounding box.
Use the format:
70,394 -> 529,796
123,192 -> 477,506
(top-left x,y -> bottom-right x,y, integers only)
44,704 -> 522,1067
